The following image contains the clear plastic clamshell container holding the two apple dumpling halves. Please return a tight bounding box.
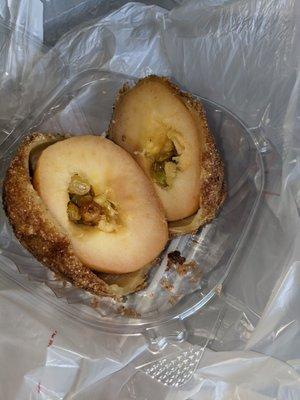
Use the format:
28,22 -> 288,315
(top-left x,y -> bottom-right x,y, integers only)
0,31 -> 266,336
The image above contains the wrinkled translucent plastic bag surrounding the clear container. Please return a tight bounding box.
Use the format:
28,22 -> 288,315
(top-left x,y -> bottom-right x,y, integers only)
0,0 -> 300,400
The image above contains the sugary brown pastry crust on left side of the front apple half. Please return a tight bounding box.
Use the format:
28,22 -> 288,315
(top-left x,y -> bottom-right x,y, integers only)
3,133 -> 113,296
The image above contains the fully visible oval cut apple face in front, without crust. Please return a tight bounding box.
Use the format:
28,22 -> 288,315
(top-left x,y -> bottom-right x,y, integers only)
34,136 -> 168,274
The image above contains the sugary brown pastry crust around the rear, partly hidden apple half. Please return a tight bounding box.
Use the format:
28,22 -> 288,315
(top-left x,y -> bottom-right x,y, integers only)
108,75 -> 227,235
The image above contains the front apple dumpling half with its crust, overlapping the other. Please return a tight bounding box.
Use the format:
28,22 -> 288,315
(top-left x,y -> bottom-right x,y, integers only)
3,133 -> 168,296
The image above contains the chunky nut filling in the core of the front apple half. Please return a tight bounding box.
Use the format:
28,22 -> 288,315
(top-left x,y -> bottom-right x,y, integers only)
67,174 -> 120,233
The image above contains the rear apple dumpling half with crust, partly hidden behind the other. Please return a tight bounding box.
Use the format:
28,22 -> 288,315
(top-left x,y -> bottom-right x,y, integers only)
109,75 -> 225,234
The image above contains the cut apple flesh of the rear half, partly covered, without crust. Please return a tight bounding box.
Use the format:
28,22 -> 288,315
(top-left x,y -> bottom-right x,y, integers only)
109,76 -> 200,221
